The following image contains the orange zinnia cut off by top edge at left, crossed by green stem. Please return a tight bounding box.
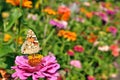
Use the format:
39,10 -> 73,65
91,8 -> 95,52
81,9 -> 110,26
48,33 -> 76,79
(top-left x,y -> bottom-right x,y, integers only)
6,0 -> 32,8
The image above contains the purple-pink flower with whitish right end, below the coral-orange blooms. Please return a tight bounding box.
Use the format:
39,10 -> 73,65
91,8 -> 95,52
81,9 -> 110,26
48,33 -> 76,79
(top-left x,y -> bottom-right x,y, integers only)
50,19 -> 67,29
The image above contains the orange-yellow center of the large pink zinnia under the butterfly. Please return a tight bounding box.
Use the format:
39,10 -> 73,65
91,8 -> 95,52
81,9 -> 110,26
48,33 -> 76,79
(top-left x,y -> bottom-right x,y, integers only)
28,54 -> 43,66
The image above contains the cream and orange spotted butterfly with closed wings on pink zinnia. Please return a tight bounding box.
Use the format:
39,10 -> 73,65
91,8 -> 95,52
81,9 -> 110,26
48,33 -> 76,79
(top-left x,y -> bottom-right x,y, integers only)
21,29 -> 41,54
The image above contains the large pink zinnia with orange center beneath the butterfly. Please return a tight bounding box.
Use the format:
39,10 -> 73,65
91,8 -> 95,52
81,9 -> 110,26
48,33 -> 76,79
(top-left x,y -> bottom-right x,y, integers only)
12,54 -> 60,80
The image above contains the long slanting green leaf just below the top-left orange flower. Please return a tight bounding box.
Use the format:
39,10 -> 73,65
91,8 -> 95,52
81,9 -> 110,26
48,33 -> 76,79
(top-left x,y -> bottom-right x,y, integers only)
5,8 -> 22,32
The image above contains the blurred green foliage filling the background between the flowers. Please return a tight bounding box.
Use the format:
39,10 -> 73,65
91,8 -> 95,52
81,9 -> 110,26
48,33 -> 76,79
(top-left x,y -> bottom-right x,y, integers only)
0,0 -> 120,80
